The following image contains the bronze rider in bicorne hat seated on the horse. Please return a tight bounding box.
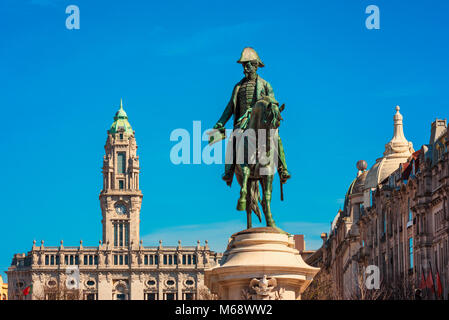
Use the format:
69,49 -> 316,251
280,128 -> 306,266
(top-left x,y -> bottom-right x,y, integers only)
214,47 -> 290,186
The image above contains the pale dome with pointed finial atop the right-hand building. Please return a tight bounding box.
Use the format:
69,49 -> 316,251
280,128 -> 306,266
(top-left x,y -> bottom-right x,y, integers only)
364,106 -> 415,189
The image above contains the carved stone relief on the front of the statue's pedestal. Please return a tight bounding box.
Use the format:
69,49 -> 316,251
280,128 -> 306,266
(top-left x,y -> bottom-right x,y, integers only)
242,275 -> 285,300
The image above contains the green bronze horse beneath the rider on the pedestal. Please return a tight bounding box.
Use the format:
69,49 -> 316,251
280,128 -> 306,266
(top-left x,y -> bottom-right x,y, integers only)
234,100 -> 284,229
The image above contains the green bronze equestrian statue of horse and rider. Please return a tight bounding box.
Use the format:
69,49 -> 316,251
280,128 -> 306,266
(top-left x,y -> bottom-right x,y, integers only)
209,47 -> 290,228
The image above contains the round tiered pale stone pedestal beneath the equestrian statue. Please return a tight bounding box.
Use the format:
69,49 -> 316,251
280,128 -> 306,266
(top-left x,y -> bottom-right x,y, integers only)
204,227 -> 320,300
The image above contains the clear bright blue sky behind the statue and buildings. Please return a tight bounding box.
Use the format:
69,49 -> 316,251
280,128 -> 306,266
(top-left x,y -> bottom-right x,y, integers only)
0,0 -> 449,275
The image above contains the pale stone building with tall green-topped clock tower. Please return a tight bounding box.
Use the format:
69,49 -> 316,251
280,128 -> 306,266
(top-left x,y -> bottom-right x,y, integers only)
7,103 -> 221,300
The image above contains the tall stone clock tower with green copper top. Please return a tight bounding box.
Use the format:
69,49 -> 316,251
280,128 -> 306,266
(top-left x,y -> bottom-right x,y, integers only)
100,100 -> 142,248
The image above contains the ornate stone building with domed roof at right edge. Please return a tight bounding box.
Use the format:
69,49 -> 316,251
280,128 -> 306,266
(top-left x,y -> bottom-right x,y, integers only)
306,107 -> 449,299
